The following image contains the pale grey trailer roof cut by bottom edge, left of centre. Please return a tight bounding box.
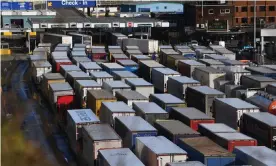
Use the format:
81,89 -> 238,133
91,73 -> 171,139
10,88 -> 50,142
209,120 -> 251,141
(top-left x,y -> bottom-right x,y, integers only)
99,148 -> 145,166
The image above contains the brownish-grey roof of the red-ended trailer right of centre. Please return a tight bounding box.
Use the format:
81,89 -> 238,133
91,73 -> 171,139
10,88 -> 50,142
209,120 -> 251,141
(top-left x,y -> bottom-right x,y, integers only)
172,107 -> 214,120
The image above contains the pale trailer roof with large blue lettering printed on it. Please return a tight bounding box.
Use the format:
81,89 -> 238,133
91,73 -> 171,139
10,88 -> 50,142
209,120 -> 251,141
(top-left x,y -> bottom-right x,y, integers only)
67,109 -> 100,124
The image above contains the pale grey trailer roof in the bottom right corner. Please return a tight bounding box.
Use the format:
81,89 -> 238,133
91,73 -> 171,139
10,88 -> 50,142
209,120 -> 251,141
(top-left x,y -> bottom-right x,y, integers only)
233,146 -> 276,166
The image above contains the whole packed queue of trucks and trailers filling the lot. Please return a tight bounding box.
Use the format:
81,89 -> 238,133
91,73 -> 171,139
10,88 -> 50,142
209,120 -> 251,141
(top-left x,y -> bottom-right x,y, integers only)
27,32 -> 276,166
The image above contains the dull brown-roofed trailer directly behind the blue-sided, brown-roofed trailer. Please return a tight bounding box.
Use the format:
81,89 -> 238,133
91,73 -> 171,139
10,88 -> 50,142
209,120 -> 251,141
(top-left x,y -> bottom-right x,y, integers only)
153,120 -> 200,144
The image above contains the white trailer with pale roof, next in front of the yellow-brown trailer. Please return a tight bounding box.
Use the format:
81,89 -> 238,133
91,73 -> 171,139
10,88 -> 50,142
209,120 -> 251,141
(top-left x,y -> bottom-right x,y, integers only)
100,101 -> 135,127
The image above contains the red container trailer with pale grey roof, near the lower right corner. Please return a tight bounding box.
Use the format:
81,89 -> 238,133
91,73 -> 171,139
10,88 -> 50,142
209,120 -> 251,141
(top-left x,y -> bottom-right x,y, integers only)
211,132 -> 257,152
